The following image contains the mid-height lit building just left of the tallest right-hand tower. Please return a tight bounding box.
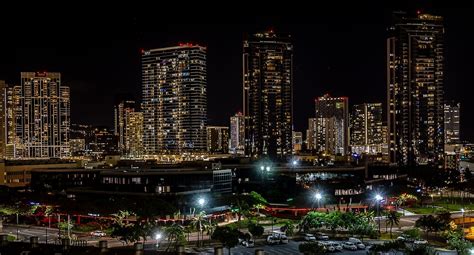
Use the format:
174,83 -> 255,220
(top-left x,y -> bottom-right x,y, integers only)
350,103 -> 384,154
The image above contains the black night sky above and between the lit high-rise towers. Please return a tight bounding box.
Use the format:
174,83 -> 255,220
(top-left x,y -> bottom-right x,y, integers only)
0,1 -> 474,141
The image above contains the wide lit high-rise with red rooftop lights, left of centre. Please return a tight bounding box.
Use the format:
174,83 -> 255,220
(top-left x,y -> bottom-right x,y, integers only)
141,44 -> 207,155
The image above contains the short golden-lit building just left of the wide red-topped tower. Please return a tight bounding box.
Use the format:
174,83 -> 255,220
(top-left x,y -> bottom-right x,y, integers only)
125,112 -> 144,157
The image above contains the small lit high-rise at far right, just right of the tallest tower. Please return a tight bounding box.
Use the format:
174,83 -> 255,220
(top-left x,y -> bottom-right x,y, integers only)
444,102 -> 461,144
